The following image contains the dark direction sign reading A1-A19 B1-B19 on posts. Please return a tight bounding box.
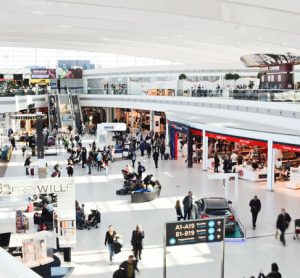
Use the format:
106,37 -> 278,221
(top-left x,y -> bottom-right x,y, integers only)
166,218 -> 224,246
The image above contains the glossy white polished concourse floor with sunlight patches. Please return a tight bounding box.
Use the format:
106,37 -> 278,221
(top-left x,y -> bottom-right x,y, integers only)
2,138 -> 300,278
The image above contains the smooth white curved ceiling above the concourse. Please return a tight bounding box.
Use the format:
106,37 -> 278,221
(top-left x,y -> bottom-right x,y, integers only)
0,0 -> 300,64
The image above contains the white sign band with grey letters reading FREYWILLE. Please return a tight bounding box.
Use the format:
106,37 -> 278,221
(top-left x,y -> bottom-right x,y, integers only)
0,178 -> 74,197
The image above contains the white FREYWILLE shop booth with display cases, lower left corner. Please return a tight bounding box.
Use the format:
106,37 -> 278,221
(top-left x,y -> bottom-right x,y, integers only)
0,178 -> 76,277
